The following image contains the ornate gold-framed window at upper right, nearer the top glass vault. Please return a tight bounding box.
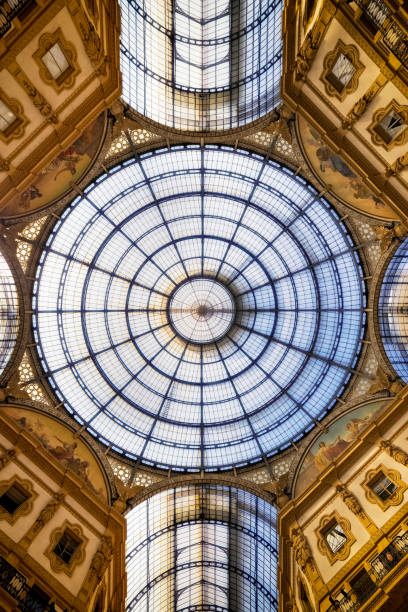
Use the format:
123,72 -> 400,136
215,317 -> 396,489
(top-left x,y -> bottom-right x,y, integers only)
321,40 -> 364,100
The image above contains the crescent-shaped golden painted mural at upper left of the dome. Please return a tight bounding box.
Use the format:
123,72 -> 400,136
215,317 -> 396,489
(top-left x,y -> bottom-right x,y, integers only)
0,114 -> 105,217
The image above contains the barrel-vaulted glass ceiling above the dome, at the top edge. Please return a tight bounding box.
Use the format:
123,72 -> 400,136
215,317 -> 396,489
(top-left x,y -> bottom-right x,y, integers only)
120,0 -> 282,131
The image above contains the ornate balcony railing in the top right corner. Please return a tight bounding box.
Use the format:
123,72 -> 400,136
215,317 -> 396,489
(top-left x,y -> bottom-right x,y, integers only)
354,0 -> 408,68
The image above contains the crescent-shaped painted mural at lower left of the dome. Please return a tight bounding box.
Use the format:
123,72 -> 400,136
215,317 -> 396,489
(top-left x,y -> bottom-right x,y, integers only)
2,406 -> 107,501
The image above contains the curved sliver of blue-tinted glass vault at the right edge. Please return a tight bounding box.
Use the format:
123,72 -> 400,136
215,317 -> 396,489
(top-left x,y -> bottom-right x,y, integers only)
378,240 -> 408,383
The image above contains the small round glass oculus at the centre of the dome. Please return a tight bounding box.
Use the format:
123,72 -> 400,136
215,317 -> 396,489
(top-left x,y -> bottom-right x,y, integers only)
168,277 -> 235,344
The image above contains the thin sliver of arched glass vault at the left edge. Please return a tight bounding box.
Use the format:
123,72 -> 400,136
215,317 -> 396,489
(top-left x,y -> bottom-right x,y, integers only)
0,253 -> 19,374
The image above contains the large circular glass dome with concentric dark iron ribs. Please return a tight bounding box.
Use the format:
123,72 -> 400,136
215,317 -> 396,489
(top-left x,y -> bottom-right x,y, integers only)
33,146 -> 365,470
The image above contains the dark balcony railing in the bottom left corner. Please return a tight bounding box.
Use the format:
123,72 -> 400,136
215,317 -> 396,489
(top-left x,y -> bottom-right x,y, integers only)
0,557 -> 55,612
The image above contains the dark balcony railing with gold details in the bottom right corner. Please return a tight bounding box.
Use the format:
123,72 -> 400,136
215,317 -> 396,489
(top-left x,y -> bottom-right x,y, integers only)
327,532 -> 408,612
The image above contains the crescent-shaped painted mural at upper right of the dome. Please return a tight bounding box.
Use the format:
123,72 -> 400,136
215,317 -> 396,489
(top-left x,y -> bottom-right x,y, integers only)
298,117 -> 397,219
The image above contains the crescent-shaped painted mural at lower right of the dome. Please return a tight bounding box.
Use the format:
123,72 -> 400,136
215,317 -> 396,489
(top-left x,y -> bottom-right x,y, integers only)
296,399 -> 388,495
